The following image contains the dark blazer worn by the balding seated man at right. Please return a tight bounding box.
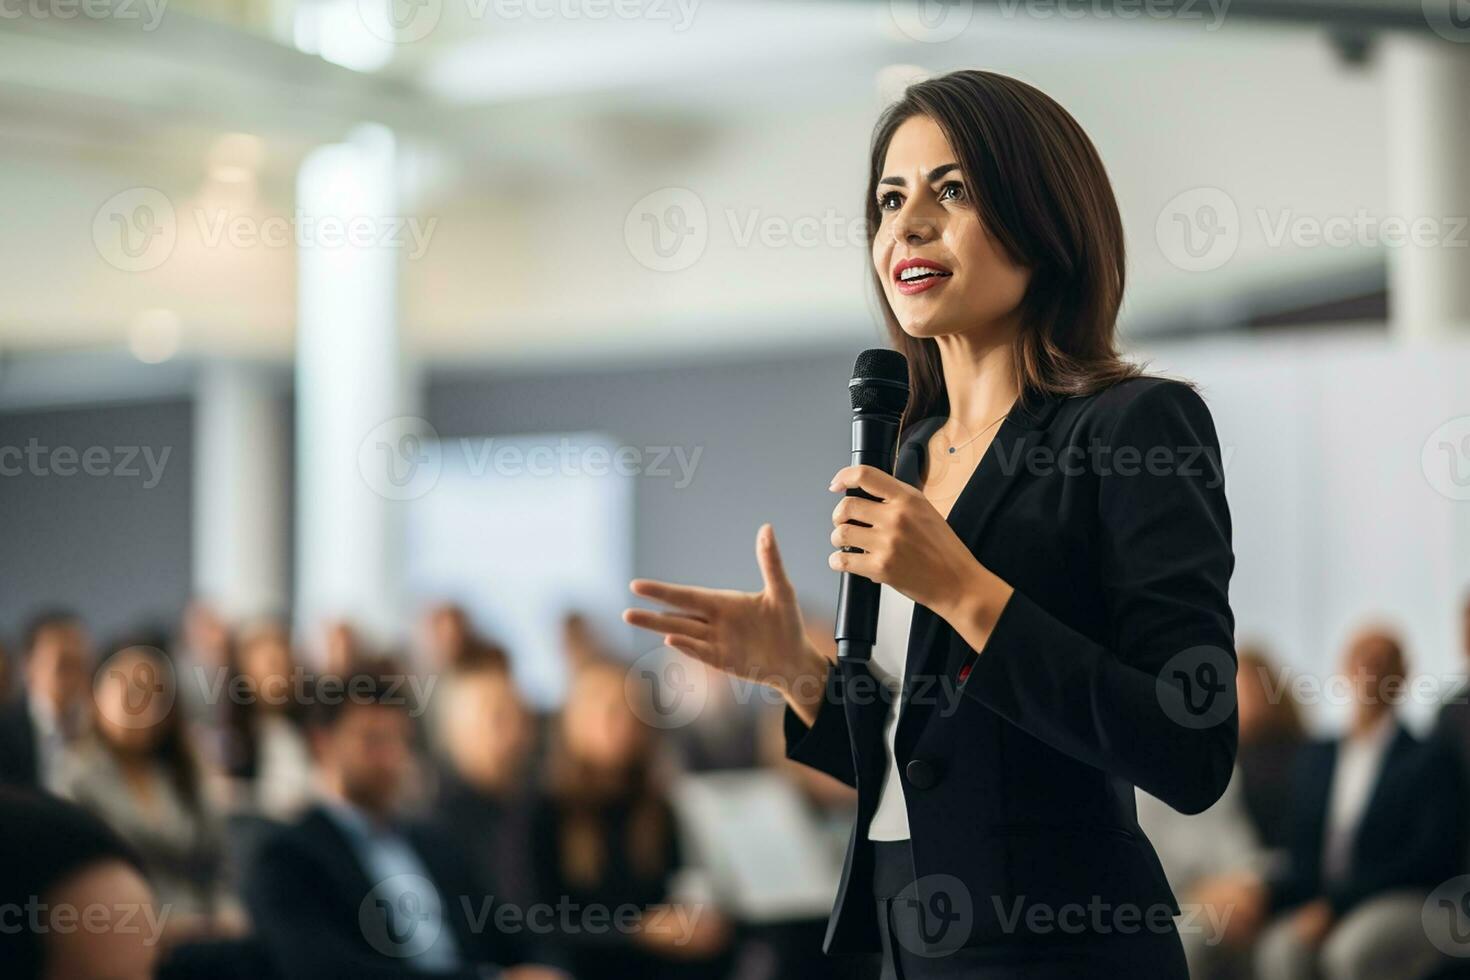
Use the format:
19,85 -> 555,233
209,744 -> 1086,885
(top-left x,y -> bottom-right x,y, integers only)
1270,721 -> 1466,915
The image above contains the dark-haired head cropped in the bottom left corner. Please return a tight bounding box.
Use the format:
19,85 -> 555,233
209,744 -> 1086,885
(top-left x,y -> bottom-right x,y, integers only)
0,788 -> 162,980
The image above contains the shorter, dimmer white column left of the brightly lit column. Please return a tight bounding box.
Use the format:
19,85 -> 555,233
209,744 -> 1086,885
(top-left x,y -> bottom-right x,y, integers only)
194,361 -> 288,620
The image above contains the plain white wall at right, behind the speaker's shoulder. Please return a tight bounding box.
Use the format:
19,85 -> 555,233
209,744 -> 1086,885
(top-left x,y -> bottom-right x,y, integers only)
1147,332 -> 1470,726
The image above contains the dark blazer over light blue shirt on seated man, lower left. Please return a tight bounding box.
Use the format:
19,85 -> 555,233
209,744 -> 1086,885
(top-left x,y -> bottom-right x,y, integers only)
241,807 -> 522,980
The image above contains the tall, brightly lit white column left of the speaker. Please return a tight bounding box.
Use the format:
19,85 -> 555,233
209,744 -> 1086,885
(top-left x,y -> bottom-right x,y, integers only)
295,125 -> 406,652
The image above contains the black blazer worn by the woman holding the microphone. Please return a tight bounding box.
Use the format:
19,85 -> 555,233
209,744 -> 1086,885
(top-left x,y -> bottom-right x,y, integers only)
785,378 -> 1236,952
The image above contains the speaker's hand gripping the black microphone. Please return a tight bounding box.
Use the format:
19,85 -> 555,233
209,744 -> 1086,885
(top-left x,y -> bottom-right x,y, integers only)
828,466 -> 1010,621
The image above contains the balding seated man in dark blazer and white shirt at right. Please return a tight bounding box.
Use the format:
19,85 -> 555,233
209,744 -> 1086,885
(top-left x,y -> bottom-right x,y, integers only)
1255,629 -> 1464,980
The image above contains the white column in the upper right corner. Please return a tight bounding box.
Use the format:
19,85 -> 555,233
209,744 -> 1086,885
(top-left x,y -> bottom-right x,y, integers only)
1383,34 -> 1470,339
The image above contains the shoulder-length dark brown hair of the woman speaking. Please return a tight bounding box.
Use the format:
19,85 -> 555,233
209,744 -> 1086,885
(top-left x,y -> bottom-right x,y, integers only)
864,69 -> 1142,422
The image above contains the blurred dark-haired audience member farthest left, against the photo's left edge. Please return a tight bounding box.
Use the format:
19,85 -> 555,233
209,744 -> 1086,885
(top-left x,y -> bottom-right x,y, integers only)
0,610 -> 91,792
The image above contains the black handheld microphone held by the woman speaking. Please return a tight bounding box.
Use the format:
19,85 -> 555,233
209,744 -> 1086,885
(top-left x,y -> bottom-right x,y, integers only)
836,347 -> 908,661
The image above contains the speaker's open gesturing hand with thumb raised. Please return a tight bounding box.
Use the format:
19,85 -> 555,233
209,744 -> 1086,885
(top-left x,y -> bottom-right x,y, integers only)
623,525 -> 829,724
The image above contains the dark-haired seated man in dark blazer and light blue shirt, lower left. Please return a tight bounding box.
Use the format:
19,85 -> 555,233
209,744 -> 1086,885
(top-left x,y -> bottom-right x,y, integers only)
245,664 -> 563,980
